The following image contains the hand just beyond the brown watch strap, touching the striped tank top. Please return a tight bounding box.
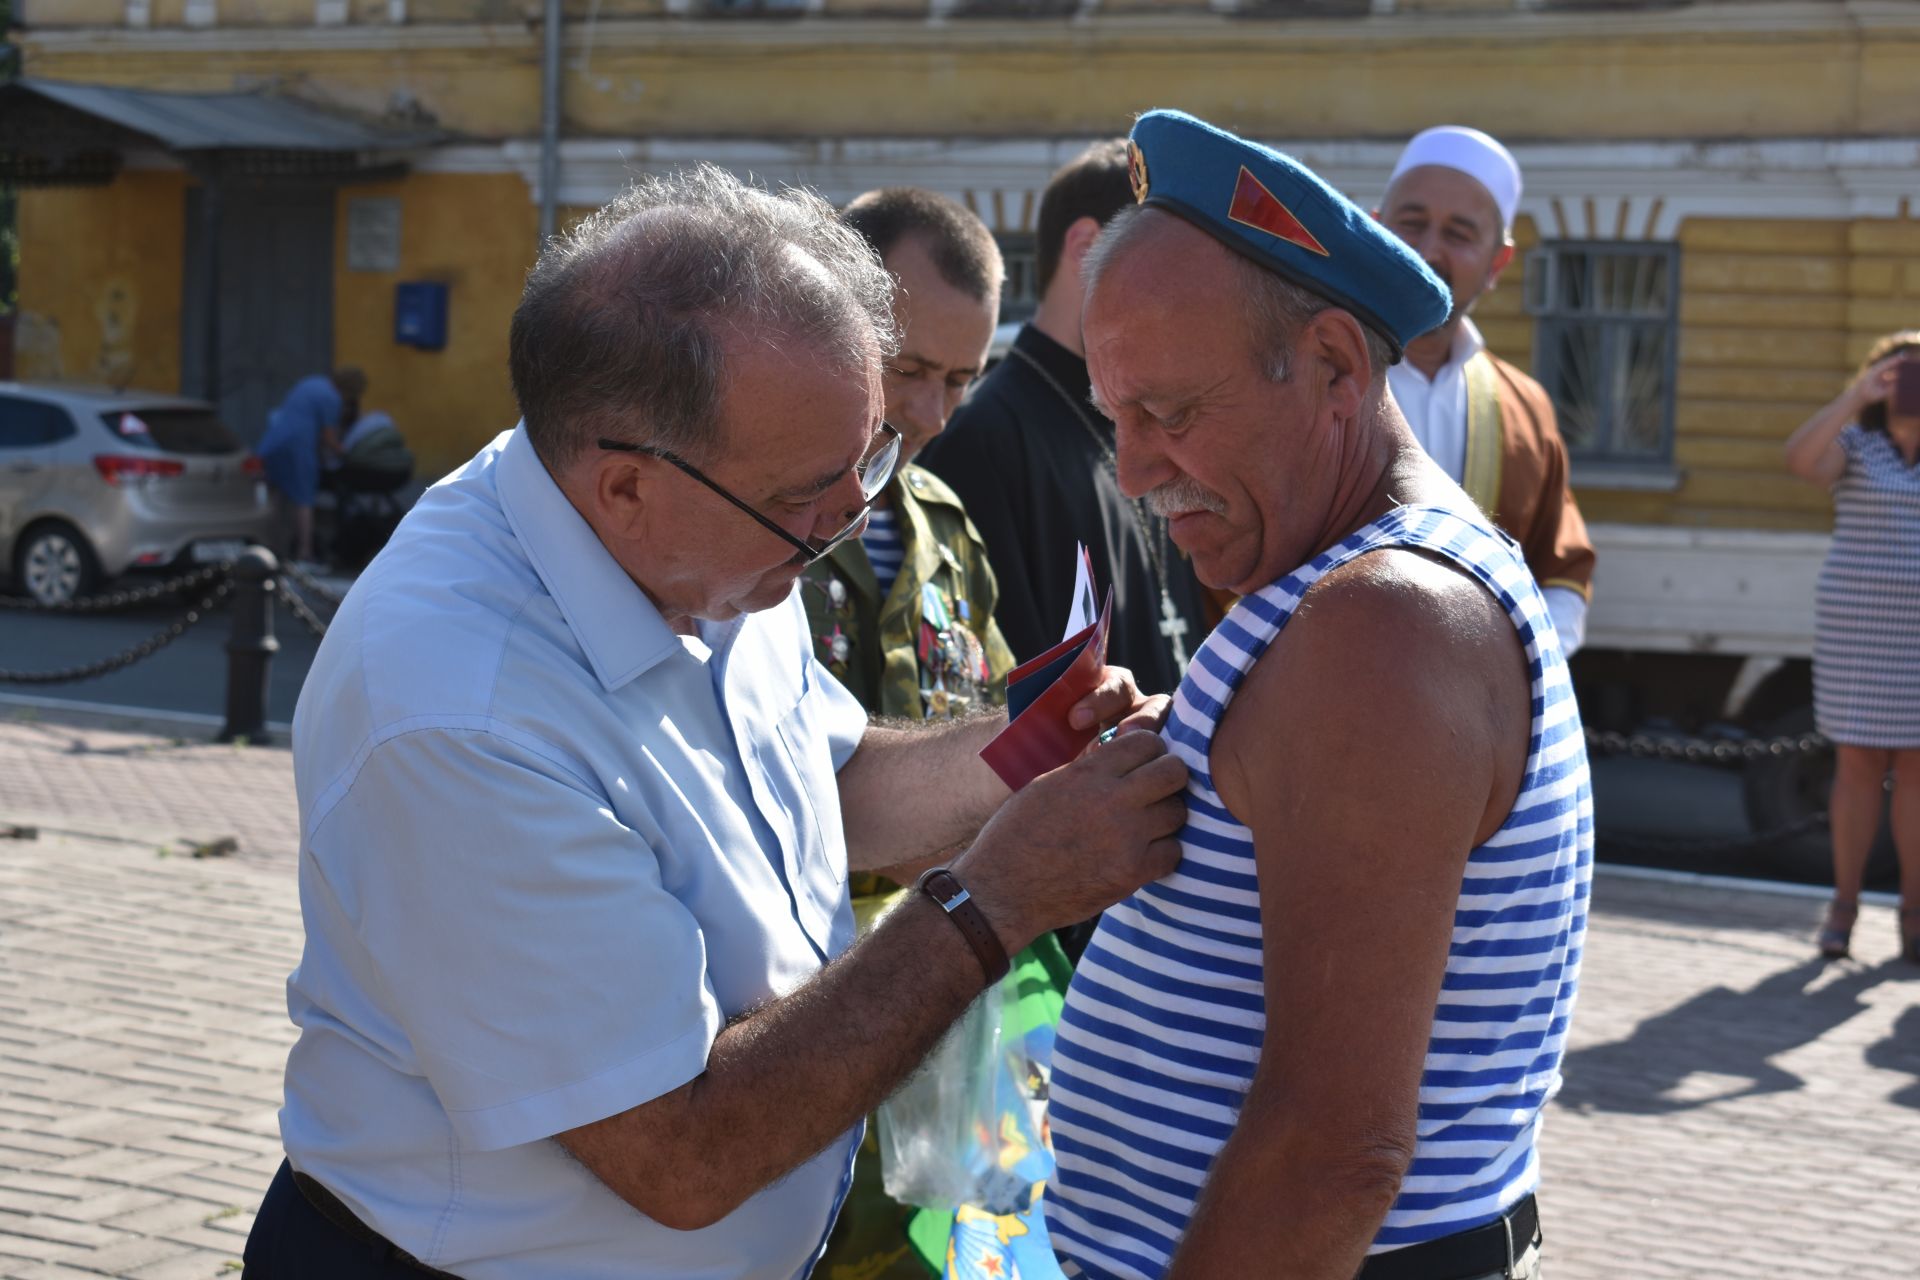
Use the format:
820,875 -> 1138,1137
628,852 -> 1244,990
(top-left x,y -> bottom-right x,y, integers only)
952,729 -> 1187,954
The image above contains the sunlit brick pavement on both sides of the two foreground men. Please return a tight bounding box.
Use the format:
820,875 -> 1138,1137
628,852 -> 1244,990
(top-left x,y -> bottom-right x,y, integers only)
0,708 -> 1920,1280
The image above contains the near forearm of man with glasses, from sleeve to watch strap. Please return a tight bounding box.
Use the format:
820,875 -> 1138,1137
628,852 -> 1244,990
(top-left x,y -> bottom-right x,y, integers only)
561,894 -> 985,1230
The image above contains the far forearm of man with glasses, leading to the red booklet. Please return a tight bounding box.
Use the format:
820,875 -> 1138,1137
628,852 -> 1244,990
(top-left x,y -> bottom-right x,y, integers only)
839,708 -> 1008,871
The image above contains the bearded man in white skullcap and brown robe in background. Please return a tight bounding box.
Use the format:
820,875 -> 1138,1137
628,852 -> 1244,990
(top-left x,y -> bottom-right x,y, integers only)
1375,125 -> 1594,656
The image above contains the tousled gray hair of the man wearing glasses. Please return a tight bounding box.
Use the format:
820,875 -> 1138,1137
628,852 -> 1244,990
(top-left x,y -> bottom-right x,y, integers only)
509,165 -> 899,470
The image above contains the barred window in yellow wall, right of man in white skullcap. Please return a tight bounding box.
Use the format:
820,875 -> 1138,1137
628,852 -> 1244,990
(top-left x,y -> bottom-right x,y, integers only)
1526,240 -> 1680,466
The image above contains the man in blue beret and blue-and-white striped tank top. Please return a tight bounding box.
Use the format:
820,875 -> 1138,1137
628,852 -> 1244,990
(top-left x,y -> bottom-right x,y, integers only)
1046,111 -> 1592,1280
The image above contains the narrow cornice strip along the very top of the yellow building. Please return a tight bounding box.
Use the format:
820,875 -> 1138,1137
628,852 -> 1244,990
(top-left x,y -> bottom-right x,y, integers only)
17,0 -> 1920,58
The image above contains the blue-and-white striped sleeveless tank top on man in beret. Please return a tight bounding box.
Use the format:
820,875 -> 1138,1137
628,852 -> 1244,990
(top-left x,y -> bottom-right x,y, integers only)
1046,507 -> 1594,1280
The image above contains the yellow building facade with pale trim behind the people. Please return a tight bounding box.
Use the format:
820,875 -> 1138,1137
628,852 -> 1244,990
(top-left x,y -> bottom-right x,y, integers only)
13,0 -> 1920,530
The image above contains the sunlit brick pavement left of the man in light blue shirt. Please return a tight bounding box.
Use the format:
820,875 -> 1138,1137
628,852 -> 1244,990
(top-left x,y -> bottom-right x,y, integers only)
0,708 -> 300,1280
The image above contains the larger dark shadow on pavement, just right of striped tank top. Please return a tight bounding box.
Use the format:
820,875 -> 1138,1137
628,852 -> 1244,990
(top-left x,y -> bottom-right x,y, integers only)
1559,960 -> 1896,1115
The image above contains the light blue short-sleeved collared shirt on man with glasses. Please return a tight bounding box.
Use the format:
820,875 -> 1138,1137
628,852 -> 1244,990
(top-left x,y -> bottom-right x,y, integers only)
280,430 -> 866,1280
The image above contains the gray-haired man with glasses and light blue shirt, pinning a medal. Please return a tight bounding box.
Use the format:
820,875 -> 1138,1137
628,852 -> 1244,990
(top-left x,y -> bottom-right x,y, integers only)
246,167 -> 1185,1280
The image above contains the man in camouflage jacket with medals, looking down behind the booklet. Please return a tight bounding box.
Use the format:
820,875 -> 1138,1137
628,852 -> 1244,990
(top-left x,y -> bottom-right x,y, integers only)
801,186 -> 1029,1280
